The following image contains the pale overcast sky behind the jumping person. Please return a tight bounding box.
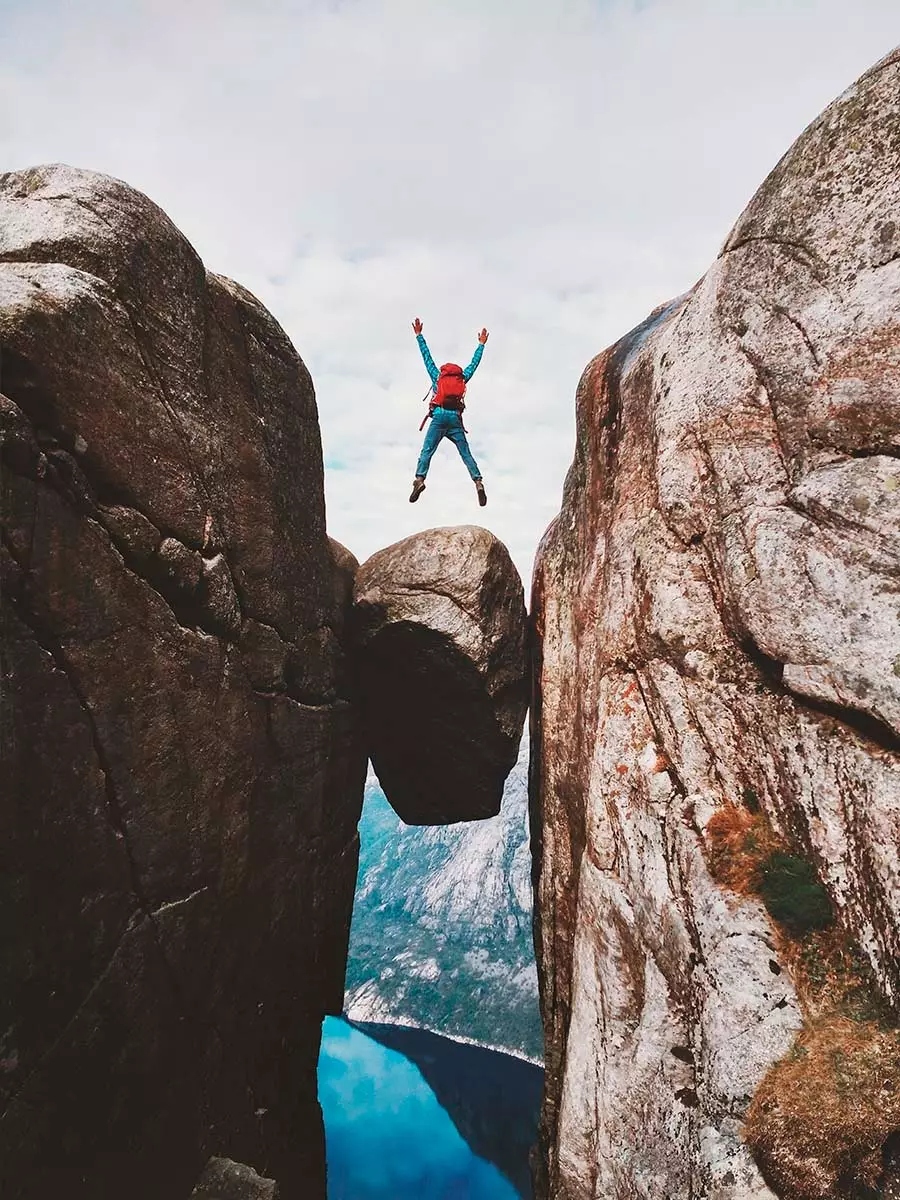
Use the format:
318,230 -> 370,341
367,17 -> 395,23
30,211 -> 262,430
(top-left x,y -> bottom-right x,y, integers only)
0,0 -> 900,577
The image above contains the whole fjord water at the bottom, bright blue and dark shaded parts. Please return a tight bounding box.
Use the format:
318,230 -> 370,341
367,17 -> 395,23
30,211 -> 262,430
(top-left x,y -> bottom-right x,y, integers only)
319,1018 -> 541,1200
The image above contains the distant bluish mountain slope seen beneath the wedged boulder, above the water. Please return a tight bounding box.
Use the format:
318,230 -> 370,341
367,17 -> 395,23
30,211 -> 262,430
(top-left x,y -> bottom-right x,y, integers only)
346,744 -> 542,1057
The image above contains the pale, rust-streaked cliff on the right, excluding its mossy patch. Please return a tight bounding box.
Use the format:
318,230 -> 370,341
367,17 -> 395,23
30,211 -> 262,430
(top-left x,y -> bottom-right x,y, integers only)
532,46 -> 900,1200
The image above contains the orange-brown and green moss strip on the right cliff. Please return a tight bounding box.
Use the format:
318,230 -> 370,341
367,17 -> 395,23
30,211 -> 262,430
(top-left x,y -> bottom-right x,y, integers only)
706,797 -> 900,1200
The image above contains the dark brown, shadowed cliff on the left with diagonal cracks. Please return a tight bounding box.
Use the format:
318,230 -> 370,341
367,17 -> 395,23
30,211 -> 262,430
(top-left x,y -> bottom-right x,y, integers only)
0,167 -> 365,1200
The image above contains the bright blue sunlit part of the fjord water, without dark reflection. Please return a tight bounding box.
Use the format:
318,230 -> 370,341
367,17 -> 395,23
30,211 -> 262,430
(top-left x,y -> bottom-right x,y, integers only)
319,1018 -> 518,1200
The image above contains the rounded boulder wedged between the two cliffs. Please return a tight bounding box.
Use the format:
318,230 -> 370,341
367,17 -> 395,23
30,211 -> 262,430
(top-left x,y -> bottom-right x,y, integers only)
354,526 -> 527,824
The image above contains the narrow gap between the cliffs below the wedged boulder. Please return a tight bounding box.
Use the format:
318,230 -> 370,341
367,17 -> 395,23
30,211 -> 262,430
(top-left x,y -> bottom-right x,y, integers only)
319,740 -> 544,1200
